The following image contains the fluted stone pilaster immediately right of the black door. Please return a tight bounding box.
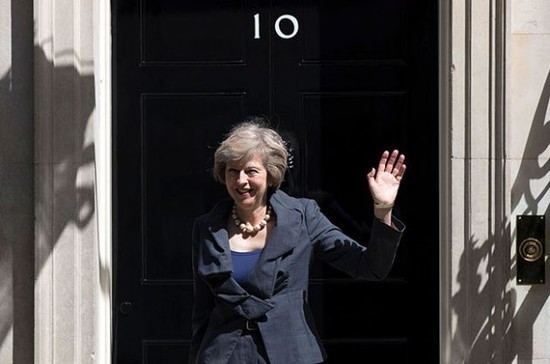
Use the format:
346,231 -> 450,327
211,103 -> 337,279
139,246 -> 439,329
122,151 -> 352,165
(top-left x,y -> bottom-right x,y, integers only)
441,0 -> 515,364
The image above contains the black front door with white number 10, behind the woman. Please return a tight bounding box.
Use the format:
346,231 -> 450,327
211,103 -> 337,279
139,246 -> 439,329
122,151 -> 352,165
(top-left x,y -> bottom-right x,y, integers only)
113,0 -> 439,363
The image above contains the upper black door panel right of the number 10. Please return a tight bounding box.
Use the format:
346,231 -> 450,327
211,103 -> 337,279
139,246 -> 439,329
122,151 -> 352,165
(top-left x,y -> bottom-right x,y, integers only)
302,0 -> 408,63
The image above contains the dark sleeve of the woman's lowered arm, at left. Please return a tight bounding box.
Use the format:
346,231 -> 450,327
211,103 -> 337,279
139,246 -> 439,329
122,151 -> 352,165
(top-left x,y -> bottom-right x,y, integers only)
189,222 -> 214,363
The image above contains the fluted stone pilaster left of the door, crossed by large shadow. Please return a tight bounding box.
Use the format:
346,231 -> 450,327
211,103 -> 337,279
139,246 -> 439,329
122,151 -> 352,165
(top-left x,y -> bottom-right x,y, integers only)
34,0 -> 98,364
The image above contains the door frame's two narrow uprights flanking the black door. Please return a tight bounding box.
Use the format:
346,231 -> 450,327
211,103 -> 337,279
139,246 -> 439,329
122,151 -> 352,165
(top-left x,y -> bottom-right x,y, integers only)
100,0 -> 453,364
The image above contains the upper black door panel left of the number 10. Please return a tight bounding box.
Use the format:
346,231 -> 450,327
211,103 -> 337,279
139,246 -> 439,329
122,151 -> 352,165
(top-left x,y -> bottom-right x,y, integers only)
141,0 -> 246,65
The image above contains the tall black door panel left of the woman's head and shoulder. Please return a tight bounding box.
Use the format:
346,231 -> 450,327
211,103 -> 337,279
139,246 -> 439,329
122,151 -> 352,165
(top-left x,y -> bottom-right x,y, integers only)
142,93 -> 245,283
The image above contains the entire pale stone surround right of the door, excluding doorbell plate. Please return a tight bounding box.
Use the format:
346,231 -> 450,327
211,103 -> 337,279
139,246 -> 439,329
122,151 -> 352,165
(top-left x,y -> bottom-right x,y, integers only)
448,0 -> 550,364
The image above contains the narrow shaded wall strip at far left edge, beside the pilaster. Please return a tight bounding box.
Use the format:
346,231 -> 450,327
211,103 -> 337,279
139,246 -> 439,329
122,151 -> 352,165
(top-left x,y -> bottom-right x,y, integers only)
0,0 -> 34,364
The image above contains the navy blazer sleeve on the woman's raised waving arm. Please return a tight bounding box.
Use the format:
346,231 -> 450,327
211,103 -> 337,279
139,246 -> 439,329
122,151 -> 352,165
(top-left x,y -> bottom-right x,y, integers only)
305,200 -> 405,280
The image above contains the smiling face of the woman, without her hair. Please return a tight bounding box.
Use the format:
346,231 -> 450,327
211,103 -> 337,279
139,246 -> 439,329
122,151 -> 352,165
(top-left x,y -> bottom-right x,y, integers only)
225,156 -> 268,209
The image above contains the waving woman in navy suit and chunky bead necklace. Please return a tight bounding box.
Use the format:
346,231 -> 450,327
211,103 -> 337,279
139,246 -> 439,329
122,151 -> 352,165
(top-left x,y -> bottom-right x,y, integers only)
190,121 -> 405,364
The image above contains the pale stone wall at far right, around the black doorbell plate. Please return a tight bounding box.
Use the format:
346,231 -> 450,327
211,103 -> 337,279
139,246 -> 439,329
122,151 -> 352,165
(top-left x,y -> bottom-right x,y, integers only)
507,0 -> 550,364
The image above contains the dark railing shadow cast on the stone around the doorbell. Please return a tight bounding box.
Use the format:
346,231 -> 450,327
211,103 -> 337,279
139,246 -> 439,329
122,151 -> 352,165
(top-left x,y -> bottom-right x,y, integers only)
451,72 -> 550,364
